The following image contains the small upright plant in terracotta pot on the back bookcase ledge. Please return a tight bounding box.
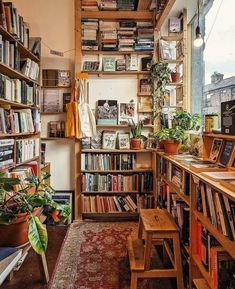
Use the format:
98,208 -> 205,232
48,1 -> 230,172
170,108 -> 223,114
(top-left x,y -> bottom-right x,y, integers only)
129,119 -> 146,150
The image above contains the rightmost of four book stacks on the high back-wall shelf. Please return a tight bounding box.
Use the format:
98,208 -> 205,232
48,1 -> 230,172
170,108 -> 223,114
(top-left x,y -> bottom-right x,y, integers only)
135,22 -> 154,51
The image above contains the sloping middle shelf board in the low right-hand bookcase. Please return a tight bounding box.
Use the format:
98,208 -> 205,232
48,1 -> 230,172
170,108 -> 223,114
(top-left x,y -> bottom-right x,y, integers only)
193,211 -> 235,259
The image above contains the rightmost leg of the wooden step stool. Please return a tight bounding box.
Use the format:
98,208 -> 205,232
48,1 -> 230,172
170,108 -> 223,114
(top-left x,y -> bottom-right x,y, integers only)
173,232 -> 184,289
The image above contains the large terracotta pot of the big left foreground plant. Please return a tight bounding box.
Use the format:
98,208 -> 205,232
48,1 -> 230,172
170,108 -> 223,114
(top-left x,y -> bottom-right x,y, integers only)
0,208 -> 41,247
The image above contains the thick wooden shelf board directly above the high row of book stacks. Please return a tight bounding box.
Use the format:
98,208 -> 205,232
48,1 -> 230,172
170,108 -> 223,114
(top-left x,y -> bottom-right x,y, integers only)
81,11 -> 153,21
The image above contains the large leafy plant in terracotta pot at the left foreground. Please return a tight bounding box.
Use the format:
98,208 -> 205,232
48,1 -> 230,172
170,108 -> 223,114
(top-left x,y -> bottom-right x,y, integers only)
0,171 -> 71,254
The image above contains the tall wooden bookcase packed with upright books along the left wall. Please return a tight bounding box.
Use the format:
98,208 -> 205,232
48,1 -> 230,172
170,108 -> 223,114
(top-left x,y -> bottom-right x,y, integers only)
0,8 -> 40,176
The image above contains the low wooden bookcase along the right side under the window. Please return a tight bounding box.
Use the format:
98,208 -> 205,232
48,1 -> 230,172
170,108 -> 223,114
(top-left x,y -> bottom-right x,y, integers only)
154,134 -> 235,289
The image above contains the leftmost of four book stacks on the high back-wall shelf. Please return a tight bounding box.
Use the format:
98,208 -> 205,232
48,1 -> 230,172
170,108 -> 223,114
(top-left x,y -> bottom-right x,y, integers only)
81,18 -> 99,50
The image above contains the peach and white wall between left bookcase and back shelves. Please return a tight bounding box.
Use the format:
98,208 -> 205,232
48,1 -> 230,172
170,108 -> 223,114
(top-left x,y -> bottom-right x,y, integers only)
13,0 -> 75,190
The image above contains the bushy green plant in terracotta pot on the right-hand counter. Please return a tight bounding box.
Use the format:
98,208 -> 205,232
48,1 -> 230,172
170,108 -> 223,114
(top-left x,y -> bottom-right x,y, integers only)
154,127 -> 185,154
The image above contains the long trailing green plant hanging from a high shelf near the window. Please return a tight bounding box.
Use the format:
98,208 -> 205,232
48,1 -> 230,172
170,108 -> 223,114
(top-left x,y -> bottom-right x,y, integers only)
149,62 -> 171,130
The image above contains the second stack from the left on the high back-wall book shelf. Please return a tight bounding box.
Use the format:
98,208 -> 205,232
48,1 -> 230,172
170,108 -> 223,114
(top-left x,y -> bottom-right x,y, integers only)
100,21 -> 118,51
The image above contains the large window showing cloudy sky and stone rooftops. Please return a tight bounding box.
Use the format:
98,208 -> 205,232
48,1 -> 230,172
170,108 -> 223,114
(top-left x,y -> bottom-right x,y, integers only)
191,0 -> 235,119
